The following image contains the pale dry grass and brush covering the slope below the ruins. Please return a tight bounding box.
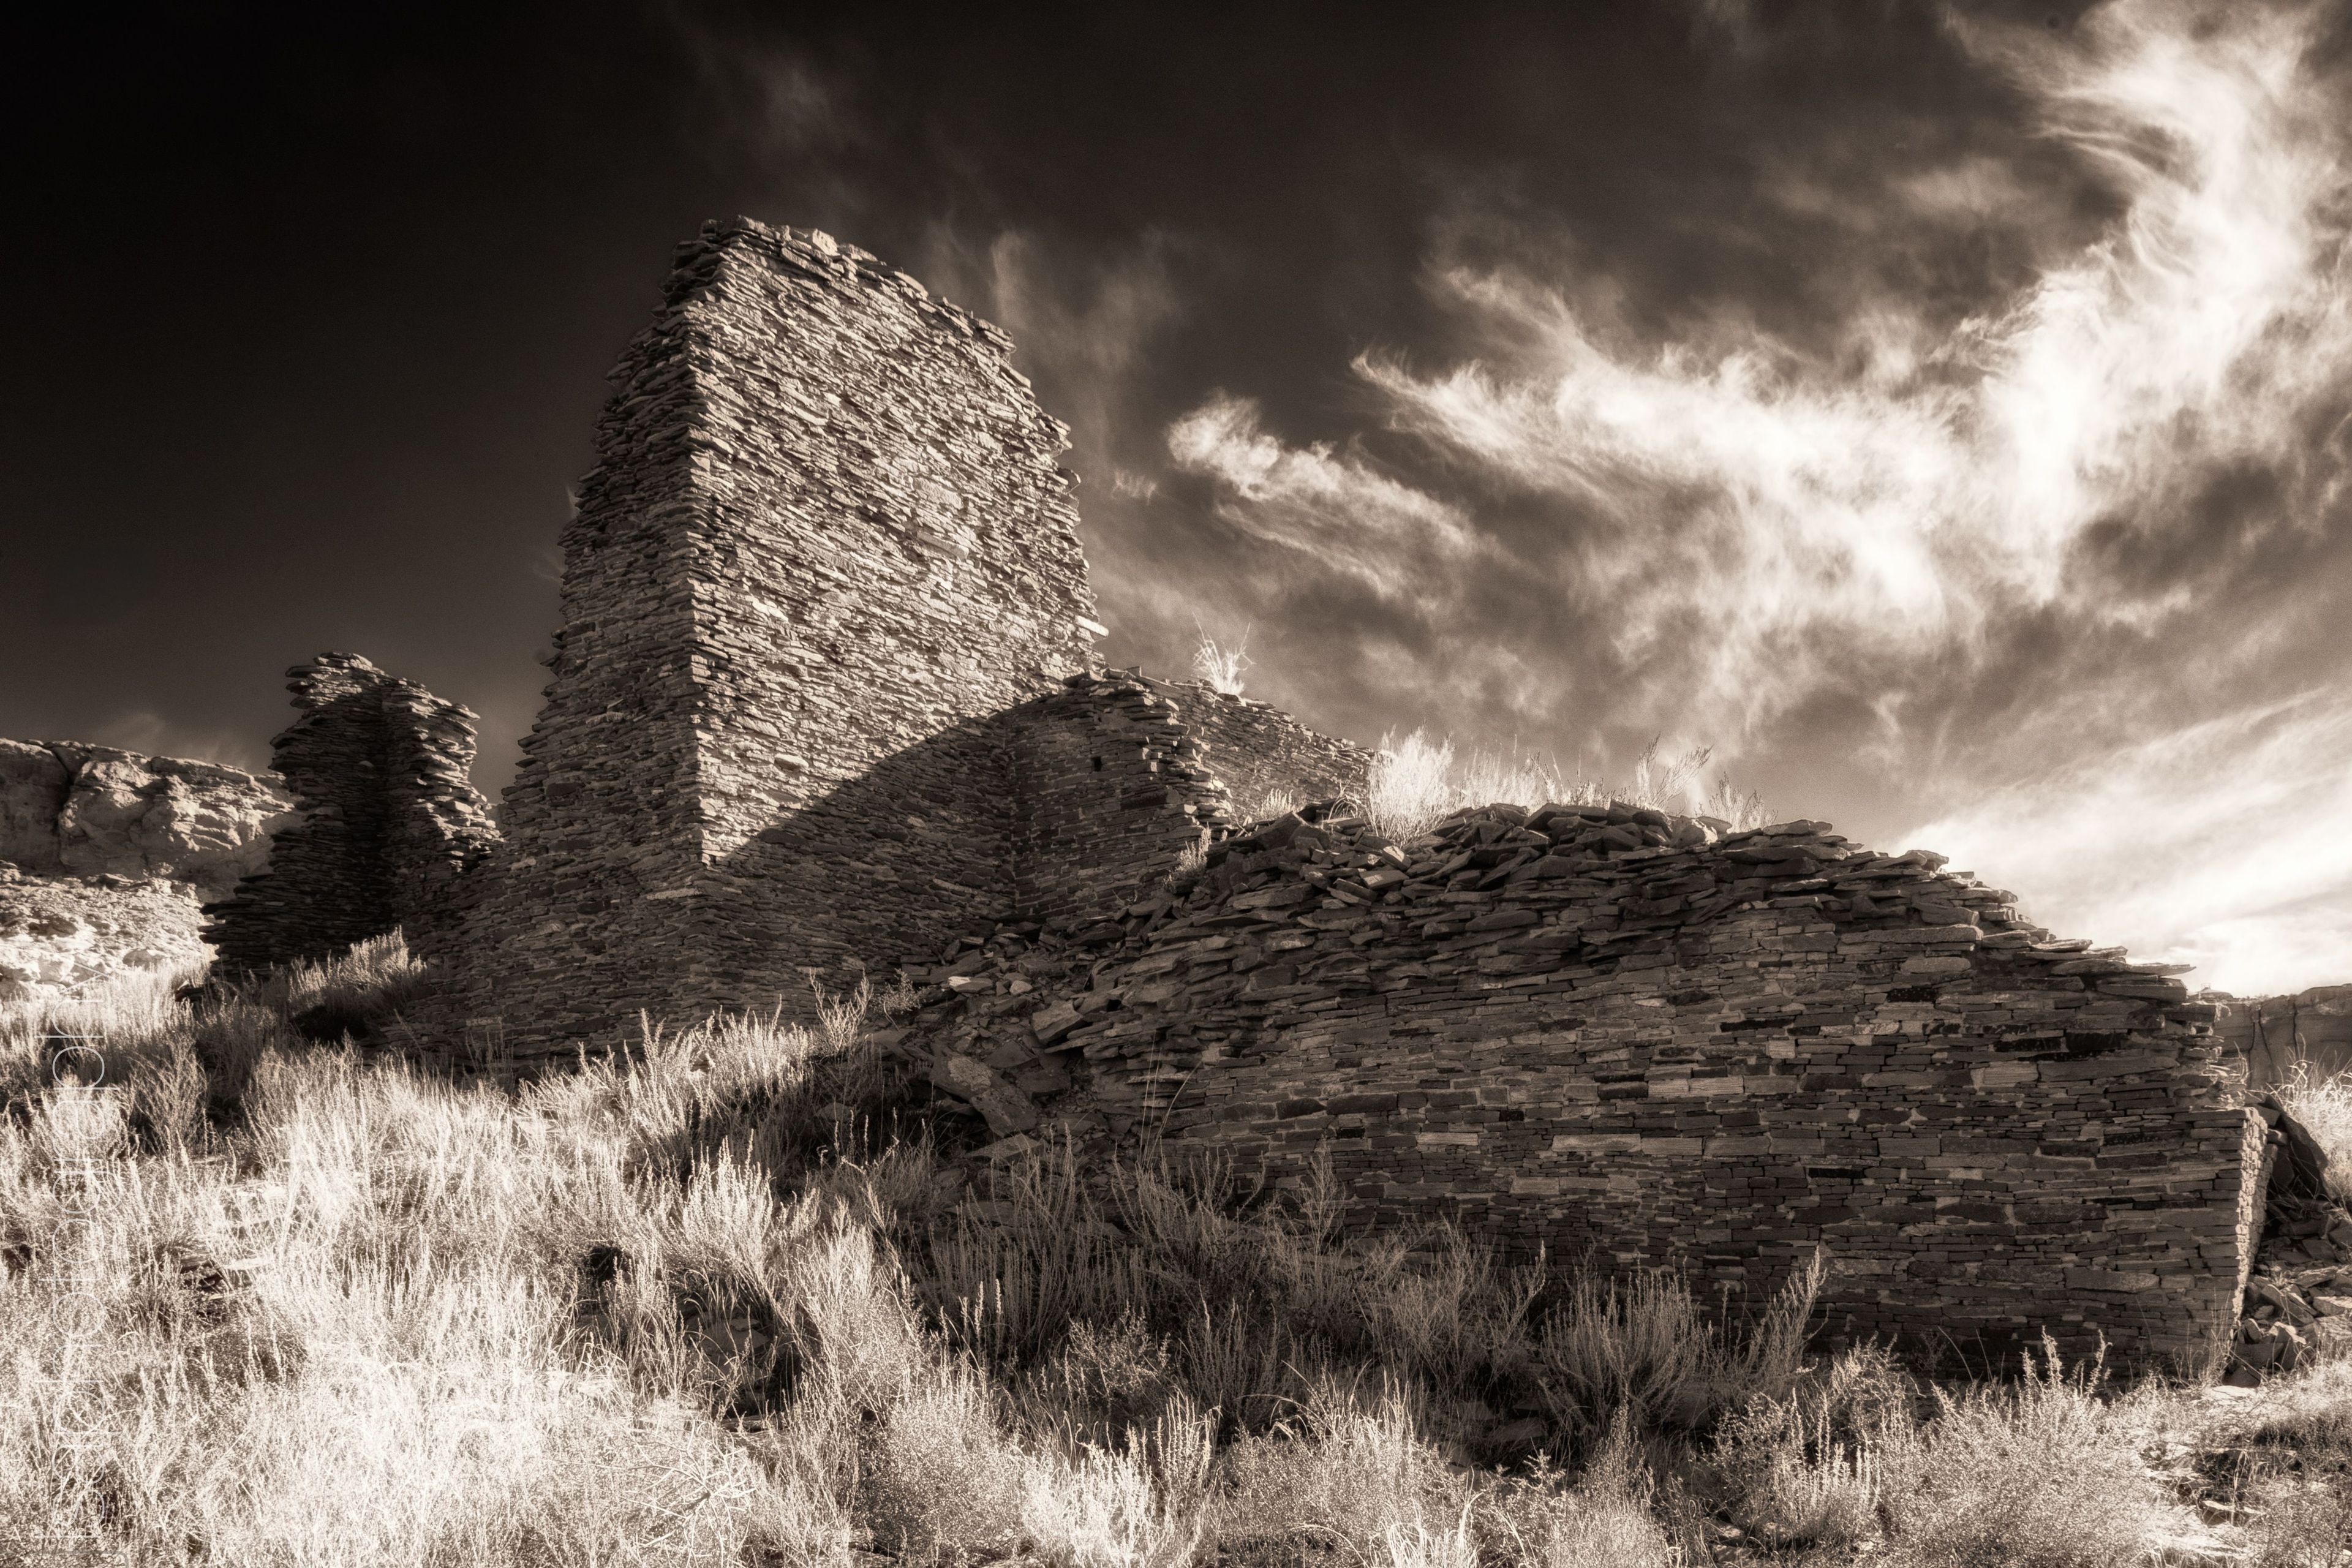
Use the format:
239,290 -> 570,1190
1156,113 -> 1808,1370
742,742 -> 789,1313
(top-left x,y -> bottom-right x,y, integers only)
0,973 -> 2352,1568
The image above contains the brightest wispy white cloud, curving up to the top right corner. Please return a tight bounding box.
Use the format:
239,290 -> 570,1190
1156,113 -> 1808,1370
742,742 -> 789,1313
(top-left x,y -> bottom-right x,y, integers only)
1360,5 -> 2352,722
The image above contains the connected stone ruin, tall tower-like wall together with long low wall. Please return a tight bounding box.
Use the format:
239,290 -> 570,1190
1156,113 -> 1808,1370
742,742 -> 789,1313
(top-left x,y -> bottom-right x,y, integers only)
197,221 -> 2270,1363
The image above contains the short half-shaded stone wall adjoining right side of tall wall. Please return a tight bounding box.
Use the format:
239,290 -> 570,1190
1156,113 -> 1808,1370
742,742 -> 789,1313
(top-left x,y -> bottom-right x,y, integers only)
1007,673 -> 1366,922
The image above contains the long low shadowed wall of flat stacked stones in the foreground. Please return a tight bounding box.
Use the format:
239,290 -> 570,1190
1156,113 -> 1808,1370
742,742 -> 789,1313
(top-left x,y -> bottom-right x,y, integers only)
918,806 -> 2263,1361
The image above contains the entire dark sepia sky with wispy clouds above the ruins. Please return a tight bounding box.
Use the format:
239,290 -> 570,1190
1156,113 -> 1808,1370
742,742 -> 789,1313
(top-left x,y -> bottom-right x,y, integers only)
0,0 -> 2352,992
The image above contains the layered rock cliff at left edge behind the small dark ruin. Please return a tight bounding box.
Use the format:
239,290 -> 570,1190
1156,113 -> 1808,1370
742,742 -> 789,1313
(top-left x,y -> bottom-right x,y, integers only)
0,741 -> 292,898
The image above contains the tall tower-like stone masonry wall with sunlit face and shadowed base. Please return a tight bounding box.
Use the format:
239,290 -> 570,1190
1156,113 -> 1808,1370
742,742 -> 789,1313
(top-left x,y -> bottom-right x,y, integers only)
451,219 -> 1101,1058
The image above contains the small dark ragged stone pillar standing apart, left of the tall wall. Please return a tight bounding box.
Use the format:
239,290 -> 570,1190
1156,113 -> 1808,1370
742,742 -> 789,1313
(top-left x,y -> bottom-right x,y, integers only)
207,654 -> 496,973
